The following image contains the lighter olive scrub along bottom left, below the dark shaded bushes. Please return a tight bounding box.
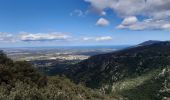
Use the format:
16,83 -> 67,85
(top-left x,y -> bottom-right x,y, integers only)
0,77 -> 115,100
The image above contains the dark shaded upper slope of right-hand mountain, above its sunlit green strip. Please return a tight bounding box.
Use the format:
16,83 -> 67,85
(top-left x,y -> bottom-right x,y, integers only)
69,42 -> 170,87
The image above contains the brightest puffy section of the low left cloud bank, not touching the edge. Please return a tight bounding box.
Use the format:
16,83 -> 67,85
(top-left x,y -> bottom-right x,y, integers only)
19,32 -> 70,41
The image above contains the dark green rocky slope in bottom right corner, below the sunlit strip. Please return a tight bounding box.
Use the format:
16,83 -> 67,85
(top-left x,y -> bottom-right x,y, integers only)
120,68 -> 170,100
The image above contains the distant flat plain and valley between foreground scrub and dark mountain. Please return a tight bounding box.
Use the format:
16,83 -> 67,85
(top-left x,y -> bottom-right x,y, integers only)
2,45 -> 128,75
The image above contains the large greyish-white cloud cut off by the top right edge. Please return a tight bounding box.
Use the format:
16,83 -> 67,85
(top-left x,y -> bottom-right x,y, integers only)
85,0 -> 170,17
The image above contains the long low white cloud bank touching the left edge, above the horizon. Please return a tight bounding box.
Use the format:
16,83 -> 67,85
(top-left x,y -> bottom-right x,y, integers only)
0,32 -> 71,42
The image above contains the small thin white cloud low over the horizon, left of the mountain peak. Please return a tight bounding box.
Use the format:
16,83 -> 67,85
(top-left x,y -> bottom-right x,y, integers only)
83,36 -> 113,41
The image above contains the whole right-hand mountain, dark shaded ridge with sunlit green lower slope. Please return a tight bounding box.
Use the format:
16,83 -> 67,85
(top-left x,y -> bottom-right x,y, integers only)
65,41 -> 170,100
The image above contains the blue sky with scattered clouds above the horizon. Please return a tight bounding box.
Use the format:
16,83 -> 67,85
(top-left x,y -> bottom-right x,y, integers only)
0,0 -> 170,47
